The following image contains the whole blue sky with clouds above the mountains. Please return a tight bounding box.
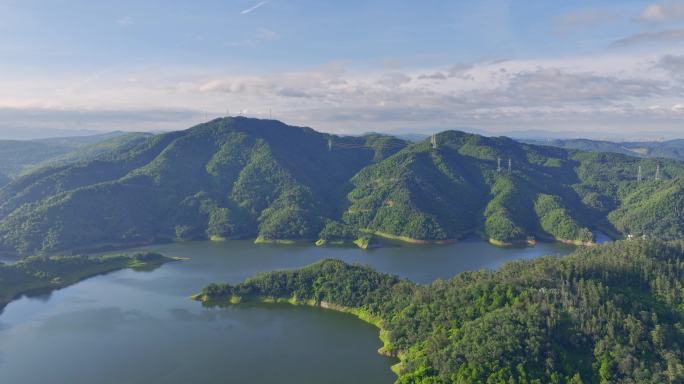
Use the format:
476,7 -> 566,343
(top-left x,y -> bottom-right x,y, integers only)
0,0 -> 684,138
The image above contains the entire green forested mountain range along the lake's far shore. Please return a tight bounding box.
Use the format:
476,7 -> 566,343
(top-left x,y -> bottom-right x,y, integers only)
0,117 -> 684,254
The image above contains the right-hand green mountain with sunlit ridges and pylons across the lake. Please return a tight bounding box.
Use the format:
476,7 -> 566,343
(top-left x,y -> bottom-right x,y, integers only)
340,131 -> 684,243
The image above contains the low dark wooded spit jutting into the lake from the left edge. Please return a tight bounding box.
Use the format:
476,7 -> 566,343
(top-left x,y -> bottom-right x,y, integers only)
0,252 -> 178,309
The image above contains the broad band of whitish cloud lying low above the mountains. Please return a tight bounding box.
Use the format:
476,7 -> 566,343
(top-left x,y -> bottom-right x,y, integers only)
0,54 -> 684,133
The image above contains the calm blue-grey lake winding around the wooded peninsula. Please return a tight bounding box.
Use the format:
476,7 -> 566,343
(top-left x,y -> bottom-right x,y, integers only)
0,239 -> 573,384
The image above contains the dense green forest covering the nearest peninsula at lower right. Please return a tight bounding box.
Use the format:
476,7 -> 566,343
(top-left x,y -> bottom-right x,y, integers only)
197,240 -> 684,384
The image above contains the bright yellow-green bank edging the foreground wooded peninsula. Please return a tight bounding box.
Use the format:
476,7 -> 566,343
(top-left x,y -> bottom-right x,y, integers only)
190,293 -> 405,377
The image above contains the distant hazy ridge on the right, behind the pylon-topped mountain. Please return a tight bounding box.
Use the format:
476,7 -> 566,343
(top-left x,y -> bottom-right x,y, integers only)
523,139 -> 684,160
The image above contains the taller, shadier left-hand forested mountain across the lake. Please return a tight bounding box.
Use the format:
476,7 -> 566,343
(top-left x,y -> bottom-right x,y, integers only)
0,118 -> 404,253
